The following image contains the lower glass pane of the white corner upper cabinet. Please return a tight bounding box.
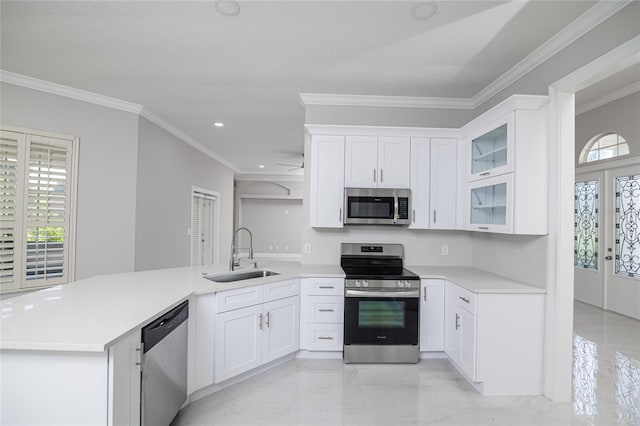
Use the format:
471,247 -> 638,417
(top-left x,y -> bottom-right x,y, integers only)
471,183 -> 507,225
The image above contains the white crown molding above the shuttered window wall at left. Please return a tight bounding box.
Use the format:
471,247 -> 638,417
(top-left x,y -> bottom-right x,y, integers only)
0,70 -> 142,114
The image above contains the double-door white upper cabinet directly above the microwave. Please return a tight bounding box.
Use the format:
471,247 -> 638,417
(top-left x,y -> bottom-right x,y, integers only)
345,136 -> 411,188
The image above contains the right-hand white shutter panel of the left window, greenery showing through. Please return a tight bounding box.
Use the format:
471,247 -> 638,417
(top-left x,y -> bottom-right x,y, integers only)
23,135 -> 72,287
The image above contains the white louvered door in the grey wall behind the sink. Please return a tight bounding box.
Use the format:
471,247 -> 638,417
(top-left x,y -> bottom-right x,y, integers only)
191,193 -> 216,265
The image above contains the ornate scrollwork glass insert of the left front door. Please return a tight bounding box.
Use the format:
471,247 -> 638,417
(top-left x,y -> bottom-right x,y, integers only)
573,180 -> 599,271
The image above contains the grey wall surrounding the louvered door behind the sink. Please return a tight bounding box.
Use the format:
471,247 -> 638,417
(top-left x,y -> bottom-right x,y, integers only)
135,117 -> 233,270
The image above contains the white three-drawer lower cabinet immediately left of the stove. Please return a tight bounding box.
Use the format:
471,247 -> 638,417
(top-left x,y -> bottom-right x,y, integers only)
300,278 -> 344,351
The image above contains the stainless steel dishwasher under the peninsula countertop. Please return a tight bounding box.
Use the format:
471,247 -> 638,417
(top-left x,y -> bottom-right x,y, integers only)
140,301 -> 189,426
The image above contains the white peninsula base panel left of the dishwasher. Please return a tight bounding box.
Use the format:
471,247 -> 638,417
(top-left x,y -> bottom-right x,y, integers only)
0,329 -> 140,426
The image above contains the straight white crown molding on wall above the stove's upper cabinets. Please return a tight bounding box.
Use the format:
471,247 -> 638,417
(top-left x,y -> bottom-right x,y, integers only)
300,93 -> 474,109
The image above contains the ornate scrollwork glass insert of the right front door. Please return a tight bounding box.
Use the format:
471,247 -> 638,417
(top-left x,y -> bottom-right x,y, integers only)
615,175 -> 640,279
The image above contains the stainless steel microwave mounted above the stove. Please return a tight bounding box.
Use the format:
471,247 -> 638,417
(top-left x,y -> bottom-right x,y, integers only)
344,188 -> 411,225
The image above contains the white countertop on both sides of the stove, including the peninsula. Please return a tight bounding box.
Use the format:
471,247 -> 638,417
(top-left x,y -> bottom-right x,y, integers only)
0,261 -> 545,352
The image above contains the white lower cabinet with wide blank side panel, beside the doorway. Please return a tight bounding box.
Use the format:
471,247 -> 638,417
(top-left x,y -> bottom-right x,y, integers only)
444,282 -> 545,395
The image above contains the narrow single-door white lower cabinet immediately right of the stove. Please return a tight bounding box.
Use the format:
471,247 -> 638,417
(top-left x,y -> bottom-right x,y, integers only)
420,279 -> 445,352
